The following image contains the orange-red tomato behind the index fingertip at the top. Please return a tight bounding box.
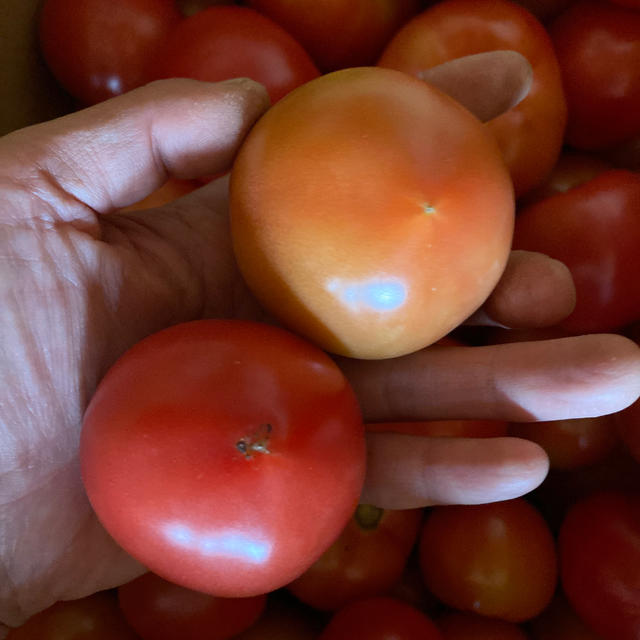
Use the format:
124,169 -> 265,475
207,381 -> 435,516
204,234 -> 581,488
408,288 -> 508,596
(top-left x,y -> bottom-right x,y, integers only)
379,0 -> 566,195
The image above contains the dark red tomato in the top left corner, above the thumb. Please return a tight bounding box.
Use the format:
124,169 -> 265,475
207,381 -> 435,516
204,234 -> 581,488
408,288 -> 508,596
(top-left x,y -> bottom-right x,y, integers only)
39,0 -> 182,104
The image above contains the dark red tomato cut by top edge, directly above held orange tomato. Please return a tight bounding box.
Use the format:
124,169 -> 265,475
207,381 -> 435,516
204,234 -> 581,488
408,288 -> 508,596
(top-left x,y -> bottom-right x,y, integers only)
248,0 -> 421,71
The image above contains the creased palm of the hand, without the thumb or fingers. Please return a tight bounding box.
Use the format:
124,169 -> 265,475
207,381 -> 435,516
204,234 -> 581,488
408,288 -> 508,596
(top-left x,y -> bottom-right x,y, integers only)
0,172 -> 259,622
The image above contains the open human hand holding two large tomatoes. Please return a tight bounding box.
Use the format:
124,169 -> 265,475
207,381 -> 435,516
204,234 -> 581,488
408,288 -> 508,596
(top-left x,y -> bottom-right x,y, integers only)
0,56 -> 640,625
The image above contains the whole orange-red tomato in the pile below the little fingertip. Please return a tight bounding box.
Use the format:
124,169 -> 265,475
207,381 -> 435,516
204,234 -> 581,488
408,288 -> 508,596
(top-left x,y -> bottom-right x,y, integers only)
420,499 -> 557,622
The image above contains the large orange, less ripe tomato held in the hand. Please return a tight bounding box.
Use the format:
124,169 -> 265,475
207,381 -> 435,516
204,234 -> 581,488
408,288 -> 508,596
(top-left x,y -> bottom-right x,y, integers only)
230,67 -> 513,358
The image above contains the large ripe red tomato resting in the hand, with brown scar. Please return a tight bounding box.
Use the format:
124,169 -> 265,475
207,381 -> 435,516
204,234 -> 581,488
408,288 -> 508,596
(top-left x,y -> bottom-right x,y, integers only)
81,320 -> 365,597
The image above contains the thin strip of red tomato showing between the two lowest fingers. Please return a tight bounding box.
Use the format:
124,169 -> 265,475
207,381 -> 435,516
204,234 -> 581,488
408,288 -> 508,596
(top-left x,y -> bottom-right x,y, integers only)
365,420 -> 509,438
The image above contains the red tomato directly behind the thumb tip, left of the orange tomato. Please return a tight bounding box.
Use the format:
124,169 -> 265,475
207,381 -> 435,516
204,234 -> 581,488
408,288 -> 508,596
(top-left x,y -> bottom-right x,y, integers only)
154,6 -> 320,102
